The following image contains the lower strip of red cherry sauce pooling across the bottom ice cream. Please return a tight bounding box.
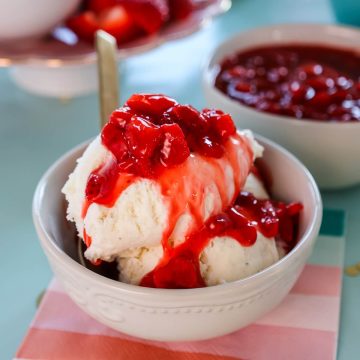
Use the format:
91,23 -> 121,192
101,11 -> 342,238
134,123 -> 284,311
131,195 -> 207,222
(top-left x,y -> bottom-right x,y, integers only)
140,192 -> 302,289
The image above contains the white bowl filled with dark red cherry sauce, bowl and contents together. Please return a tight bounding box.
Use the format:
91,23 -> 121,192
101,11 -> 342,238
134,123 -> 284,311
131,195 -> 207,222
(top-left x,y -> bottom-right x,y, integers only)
203,24 -> 360,189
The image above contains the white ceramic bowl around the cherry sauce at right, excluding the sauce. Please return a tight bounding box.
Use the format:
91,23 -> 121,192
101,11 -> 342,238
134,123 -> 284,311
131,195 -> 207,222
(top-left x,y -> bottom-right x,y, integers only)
203,24 -> 360,189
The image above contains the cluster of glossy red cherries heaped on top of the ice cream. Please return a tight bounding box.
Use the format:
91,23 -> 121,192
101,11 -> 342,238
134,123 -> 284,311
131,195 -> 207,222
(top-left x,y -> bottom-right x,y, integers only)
95,94 -> 236,183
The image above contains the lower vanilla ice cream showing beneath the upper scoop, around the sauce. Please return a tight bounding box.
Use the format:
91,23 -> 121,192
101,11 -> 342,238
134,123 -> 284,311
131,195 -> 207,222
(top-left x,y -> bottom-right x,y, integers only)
117,173 -> 283,286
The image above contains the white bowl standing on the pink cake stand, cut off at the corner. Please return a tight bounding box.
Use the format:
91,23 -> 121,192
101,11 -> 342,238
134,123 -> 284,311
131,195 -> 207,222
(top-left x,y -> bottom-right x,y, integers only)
0,0 -> 81,41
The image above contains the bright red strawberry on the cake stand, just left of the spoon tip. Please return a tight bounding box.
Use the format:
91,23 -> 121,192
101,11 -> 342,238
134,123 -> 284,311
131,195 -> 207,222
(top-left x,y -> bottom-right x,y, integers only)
66,11 -> 99,42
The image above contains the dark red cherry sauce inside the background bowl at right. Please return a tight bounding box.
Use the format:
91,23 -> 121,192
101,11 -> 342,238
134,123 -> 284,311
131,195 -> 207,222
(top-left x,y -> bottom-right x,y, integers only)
215,45 -> 360,122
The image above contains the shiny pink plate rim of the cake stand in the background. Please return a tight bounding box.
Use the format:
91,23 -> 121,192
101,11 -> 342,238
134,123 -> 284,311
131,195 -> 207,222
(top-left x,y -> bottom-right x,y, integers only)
0,0 -> 231,67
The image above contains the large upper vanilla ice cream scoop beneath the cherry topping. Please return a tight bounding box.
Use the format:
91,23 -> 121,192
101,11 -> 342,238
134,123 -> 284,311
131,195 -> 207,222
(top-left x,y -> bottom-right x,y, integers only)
63,132 -> 262,261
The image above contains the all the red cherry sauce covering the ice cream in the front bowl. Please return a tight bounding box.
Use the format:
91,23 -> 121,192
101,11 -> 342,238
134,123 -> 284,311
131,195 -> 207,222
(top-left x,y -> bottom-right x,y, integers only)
82,94 -> 301,288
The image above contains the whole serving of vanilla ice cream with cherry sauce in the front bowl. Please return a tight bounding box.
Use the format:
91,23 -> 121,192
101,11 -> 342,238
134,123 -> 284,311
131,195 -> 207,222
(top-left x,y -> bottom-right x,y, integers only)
62,94 -> 299,288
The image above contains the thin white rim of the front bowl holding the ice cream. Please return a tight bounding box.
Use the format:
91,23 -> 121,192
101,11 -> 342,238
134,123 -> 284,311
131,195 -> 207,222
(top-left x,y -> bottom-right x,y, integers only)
32,134 -> 323,299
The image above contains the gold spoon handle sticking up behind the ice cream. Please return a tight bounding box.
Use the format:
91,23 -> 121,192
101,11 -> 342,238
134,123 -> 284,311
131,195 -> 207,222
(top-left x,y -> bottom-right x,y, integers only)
96,30 -> 119,129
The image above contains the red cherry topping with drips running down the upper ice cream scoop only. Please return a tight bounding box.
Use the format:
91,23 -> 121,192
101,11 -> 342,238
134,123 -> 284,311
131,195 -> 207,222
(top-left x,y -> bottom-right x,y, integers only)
82,94 -> 245,249
